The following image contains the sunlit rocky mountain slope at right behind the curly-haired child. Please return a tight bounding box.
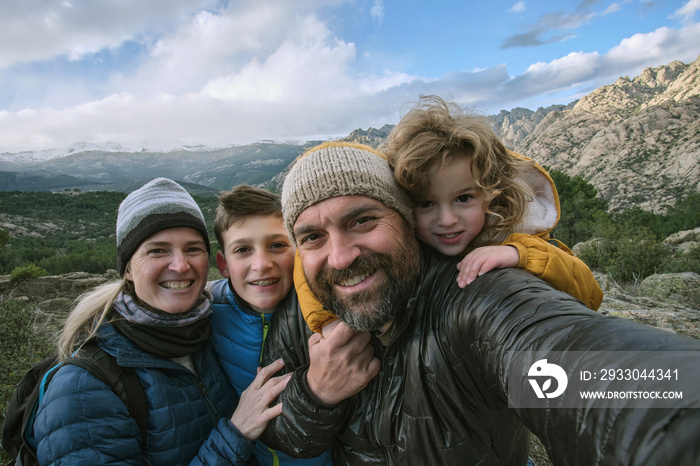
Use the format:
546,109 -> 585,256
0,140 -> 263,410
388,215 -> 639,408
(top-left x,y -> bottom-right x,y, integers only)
486,57 -> 700,213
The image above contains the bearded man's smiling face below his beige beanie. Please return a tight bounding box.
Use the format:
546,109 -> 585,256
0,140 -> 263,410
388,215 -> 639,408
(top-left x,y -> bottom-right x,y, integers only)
294,196 -> 418,332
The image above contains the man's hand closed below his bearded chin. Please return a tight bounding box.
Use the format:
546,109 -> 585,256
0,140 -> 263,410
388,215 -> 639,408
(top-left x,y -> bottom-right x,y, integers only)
306,322 -> 381,405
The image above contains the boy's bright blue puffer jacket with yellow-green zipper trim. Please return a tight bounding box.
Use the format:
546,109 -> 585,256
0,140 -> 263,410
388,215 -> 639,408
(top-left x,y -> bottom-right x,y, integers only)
211,279 -> 333,466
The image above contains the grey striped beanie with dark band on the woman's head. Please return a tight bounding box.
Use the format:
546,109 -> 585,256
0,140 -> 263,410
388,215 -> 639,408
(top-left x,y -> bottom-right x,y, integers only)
117,178 -> 211,275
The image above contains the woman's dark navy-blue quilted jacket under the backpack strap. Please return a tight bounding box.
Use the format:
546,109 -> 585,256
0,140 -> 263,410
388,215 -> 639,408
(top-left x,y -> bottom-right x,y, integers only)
34,324 -> 253,466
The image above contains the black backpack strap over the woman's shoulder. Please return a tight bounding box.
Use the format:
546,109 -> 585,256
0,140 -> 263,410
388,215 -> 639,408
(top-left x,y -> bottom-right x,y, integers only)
66,341 -> 148,448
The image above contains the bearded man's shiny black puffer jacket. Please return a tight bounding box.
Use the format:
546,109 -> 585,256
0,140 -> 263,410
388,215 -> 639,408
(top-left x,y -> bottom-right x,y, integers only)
264,249 -> 700,466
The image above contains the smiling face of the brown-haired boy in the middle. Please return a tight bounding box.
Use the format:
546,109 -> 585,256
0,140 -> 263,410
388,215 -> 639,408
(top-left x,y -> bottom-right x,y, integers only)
216,215 -> 295,313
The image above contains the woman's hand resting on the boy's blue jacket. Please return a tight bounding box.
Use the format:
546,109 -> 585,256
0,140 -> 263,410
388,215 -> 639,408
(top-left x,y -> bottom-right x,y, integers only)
231,359 -> 292,440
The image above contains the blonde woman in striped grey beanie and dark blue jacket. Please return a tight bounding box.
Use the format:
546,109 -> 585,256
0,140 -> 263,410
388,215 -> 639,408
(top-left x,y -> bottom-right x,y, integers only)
34,178 -> 288,465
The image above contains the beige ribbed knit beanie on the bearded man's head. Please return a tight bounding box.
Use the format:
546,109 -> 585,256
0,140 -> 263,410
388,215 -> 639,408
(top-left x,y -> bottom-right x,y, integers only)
282,142 -> 415,242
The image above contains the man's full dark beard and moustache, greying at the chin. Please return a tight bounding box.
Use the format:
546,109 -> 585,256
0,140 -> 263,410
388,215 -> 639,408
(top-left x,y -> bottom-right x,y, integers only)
307,230 -> 420,332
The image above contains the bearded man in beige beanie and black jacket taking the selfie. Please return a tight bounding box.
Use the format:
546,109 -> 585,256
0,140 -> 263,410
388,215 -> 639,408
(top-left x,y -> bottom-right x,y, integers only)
264,143 -> 700,466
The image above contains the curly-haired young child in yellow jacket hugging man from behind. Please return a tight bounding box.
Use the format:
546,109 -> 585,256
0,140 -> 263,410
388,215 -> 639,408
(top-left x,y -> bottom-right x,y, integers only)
295,96 -> 603,333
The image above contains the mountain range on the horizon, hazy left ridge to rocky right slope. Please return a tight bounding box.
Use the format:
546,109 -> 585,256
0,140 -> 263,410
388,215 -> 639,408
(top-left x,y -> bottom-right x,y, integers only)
0,57 -> 700,213
